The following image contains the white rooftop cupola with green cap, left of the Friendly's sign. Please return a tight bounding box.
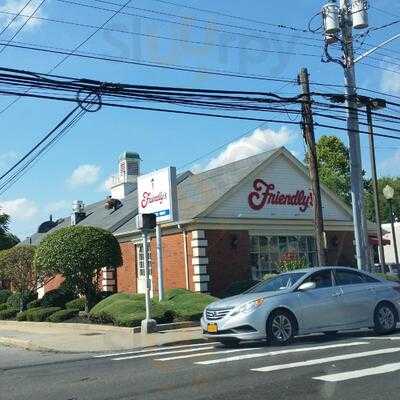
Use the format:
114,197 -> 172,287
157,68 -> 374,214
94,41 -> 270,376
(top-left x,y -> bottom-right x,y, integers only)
111,151 -> 140,200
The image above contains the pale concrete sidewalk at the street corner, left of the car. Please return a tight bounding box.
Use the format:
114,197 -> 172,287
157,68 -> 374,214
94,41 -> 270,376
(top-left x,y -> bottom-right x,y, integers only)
0,321 -> 202,353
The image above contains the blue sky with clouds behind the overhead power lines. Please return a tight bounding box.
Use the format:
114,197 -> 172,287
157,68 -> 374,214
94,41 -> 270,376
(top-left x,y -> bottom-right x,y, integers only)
0,0 -> 400,238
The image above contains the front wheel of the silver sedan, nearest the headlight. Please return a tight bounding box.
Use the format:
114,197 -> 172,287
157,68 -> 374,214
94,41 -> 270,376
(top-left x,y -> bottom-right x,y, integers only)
267,310 -> 296,346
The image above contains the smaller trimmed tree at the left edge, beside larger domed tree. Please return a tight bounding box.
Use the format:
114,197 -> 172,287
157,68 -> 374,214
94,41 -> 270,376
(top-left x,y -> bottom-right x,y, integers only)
0,245 -> 52,311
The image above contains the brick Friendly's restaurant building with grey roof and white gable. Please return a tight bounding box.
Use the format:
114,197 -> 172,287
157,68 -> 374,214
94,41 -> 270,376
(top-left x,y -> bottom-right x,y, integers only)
27,147 -> 374,296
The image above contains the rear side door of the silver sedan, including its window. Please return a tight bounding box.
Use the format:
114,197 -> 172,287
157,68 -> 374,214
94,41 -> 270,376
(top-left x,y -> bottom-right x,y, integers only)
334,269 -> 376,328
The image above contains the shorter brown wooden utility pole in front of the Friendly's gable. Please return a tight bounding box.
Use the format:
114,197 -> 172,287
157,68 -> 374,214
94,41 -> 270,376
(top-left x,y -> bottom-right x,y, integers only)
299,68 -> 326,267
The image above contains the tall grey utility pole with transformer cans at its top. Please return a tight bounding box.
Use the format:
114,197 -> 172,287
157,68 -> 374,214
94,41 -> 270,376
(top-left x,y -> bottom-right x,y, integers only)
323,0 -> 369,269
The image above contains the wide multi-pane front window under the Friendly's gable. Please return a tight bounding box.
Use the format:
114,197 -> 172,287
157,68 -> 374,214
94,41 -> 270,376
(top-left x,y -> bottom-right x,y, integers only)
250,236 -> 317,280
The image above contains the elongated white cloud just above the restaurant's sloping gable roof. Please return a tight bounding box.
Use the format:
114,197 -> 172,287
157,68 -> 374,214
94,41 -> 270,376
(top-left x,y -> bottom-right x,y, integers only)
200,127 -> 293,170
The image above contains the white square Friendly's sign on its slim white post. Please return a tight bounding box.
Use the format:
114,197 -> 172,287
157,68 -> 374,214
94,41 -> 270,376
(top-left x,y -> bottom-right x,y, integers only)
138,167 -> 178,301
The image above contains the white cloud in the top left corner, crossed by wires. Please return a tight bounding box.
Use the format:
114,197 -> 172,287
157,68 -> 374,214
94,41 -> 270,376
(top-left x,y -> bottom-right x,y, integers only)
0,0 -> 43,32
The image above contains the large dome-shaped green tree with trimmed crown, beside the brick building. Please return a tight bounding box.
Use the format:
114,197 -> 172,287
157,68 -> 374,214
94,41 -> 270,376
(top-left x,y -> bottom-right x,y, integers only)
35,226 -> 122,312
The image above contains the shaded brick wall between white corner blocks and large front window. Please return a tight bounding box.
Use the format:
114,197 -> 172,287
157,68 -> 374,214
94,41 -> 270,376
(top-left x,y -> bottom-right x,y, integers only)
206,231 -> 251,296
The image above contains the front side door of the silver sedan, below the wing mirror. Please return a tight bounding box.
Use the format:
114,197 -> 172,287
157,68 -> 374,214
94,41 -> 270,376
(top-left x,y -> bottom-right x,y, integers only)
297,269 -> 342,332
